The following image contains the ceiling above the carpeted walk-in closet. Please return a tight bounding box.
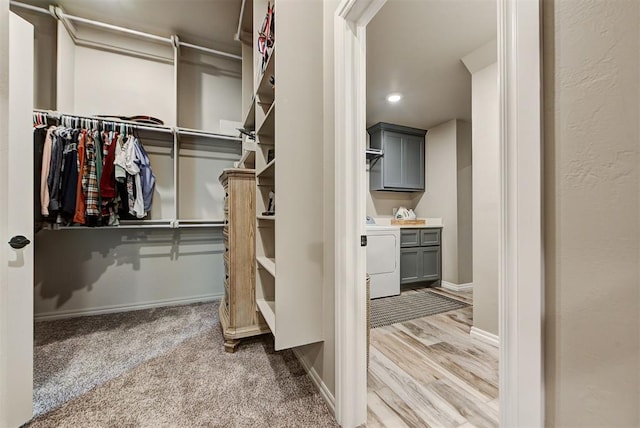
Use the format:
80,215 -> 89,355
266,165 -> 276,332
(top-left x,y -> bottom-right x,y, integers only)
18,0 -> 242,54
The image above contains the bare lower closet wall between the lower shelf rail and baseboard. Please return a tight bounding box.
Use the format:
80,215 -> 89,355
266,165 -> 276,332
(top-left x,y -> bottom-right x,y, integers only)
34,229 -> 224,317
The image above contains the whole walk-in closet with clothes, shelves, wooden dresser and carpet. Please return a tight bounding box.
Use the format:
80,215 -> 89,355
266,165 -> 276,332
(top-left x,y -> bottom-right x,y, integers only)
3,0 -> 334,427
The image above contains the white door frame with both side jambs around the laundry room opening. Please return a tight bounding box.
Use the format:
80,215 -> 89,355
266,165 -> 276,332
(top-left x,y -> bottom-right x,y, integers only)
334,0 -> 544,428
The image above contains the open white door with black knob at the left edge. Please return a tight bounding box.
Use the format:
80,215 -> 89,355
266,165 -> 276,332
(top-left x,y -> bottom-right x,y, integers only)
0,13 -> 34,427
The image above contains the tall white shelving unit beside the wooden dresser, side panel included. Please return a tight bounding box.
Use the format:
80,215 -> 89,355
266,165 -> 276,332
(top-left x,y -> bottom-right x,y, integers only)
243,0 -> 324,350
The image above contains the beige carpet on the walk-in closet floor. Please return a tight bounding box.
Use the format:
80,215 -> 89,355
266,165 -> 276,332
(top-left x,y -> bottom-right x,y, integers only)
28,303 -> 337,427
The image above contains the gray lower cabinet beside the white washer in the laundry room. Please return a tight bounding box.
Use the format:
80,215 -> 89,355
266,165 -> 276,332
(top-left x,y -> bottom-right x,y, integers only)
400,228 -> 442,284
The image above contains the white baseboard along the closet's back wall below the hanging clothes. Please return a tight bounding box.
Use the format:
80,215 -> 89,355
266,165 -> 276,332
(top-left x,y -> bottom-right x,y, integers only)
33,293 -> 224,321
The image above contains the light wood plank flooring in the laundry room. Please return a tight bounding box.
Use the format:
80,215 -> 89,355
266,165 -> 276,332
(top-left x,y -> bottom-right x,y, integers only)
367,288 -> 499,428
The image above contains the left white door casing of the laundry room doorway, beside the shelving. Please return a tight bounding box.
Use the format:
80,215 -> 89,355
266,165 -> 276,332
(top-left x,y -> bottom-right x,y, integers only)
334,0 -> 386,427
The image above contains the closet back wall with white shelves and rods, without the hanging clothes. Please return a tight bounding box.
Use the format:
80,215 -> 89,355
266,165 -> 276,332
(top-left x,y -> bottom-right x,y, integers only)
12,2 -> 242,320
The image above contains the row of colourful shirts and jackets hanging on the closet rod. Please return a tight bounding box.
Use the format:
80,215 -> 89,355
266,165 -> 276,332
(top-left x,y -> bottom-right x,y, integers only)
33,114 -> 155,230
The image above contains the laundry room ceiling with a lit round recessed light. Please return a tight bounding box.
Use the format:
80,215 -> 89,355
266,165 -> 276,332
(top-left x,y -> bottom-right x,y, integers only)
367,0 -> 497,129
